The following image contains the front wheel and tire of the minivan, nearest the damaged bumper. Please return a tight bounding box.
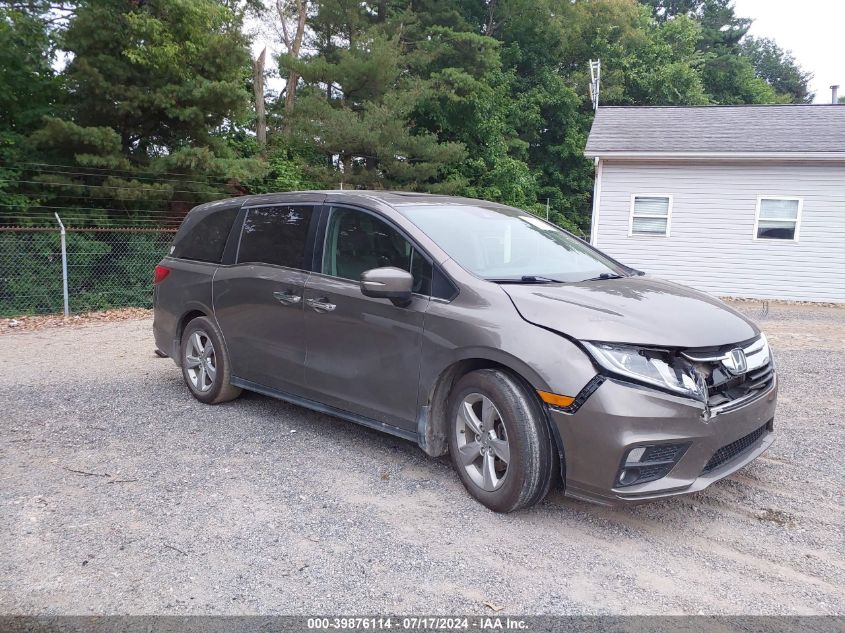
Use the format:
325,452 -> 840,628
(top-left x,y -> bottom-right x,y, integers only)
447,369 -> 555,512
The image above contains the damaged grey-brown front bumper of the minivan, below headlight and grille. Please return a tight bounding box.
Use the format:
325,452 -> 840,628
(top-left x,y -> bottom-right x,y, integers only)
550,378 -> 778,504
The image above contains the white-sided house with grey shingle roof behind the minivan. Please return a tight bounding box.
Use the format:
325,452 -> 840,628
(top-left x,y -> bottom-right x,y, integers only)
585,105 -> 845,303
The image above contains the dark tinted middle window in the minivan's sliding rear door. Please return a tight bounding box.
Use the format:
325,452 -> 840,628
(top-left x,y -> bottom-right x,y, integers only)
238,206 -> 314,268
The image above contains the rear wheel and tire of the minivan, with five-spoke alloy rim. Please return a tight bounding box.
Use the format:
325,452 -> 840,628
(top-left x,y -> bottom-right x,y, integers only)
179,317 -> 241,404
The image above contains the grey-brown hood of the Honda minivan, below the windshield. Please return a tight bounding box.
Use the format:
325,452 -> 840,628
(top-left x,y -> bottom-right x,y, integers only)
501,276 -> 760,347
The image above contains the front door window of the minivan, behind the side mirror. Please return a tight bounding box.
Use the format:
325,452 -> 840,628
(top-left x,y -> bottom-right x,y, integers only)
323,207 -> 432,295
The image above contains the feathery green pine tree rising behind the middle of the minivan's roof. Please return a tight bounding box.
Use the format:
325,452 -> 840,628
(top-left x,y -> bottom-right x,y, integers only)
285,0 -> 464,189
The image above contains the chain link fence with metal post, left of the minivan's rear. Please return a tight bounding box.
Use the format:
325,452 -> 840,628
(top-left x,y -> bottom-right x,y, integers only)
0,227 -> 176,317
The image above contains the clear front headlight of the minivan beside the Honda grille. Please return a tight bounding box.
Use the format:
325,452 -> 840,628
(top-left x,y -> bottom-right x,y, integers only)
584,341 -> 707,402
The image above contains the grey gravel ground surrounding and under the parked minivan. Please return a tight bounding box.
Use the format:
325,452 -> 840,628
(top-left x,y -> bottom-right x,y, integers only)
0,303 -> 845,614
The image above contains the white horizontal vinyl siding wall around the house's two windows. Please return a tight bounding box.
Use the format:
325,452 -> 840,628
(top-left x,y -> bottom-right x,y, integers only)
593,159 -> 845,303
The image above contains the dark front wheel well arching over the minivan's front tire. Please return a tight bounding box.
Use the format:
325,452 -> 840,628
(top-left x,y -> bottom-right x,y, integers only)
417,358 -> 566,481
